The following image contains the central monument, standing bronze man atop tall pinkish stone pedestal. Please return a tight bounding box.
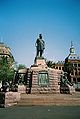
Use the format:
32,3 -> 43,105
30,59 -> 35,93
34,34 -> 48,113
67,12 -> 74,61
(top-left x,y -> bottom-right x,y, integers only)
27,34 -> 61,94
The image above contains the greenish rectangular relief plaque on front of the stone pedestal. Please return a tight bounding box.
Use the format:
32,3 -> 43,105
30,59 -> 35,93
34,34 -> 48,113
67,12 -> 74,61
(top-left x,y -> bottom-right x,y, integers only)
38,71 -> 49,87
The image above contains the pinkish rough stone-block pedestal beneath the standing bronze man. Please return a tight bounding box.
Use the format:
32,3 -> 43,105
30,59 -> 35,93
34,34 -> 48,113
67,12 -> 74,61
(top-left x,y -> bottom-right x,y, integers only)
30,59 -> 61,94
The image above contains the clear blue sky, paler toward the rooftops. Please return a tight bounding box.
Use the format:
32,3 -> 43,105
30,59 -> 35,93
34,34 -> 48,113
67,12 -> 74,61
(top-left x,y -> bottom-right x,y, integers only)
0,0 -> 80,67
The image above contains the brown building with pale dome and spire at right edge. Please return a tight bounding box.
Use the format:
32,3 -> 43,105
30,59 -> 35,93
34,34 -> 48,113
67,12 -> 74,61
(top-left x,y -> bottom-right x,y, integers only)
64,42 -> 80,89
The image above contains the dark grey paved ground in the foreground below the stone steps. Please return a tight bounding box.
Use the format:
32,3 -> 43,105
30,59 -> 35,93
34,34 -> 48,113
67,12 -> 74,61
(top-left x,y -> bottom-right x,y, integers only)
0,106 -> 80,119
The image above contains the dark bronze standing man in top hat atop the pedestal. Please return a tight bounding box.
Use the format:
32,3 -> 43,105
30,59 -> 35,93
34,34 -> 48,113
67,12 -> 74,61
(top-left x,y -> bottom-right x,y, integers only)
36,34 -> 45,57
